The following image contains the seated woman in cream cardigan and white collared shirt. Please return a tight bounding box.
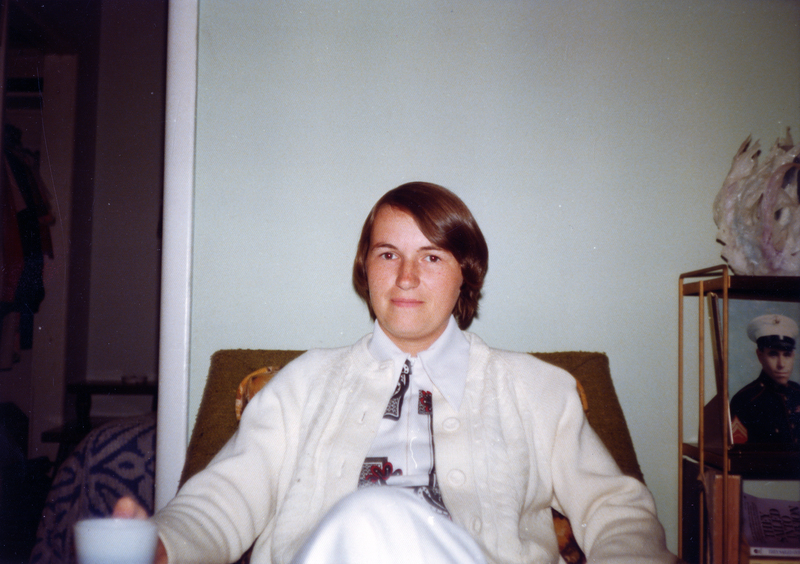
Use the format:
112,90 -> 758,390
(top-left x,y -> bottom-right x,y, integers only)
117,182 -> 674,563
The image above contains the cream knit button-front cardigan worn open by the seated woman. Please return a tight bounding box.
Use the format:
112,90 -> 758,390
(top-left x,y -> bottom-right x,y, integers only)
154,333 -> 675,564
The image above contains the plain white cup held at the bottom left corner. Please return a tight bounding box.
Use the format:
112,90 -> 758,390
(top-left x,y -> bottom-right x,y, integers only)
75,517 -> 158,564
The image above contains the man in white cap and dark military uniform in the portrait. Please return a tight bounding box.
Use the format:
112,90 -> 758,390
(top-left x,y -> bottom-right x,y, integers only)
731,314 -> 800,448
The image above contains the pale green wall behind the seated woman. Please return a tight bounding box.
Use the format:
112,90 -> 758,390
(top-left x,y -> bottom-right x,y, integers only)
190,0 -> 800,550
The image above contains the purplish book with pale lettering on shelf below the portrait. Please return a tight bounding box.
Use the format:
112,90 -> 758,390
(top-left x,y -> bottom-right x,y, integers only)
742,493 -> 800,557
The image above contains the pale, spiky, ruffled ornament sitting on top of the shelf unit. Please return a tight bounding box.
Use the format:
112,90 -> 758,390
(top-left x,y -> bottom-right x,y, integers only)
714,128 -> 800,276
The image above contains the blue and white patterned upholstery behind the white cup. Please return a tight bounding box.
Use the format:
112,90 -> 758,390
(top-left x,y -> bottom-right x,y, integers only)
31,413 -> 156,564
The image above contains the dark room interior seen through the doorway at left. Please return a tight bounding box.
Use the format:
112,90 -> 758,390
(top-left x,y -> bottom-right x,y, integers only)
0,0 -> 167,563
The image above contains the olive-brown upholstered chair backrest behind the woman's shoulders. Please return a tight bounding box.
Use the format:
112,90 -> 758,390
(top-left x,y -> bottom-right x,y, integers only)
180,349 -> 643,485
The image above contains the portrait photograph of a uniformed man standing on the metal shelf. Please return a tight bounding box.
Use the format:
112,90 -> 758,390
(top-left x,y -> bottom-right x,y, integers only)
728,299 -> 800,449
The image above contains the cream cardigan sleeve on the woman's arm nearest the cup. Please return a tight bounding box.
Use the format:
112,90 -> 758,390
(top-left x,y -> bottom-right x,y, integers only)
153,373 -> 300,564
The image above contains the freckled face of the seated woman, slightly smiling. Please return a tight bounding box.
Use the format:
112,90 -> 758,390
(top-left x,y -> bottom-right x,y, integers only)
366,206 -> 463,355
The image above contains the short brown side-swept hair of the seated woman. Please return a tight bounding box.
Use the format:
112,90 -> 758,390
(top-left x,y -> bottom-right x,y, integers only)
353,182 -> 489,329
